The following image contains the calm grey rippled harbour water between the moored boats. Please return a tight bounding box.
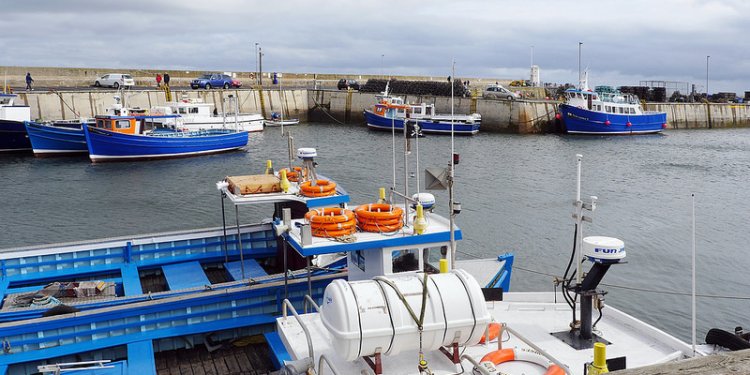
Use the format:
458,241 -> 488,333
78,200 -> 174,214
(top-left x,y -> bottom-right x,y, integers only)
0,124 -> 750,340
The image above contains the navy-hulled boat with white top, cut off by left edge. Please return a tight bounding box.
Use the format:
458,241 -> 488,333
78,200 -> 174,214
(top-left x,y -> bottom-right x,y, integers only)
0,92 -> 31,152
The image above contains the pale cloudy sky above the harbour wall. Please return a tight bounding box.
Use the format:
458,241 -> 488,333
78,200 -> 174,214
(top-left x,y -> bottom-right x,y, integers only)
0,0 -> 750,96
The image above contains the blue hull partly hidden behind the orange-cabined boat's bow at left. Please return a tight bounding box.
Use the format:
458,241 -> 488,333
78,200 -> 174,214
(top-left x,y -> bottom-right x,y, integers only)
26,122 -> 89,156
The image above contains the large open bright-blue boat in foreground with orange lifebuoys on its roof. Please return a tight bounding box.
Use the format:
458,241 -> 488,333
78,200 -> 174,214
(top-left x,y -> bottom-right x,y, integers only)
0,145 -> 512,375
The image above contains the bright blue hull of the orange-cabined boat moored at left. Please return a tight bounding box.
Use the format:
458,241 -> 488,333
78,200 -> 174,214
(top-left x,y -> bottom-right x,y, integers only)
83,126 -> 248,162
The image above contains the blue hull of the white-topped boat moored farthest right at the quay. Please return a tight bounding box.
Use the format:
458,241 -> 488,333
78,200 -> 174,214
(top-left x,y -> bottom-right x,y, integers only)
559,104 -> 667,135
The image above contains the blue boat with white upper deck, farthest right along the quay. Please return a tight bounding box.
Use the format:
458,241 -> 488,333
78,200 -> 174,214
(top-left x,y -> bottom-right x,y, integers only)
559,87 -> 667,135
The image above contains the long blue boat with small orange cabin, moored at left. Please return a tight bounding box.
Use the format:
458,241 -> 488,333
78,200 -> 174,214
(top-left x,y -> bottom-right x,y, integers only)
83,116 -> 248,162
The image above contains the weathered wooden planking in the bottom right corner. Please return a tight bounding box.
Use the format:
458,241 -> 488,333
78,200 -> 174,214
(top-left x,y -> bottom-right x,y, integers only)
611,349 -> 750,375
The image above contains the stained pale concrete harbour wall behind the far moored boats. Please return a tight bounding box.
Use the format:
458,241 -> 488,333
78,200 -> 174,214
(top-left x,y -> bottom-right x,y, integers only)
11,89 -> 750,134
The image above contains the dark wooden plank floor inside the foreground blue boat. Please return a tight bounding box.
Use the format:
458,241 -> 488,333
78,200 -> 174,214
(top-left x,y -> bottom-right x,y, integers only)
155,342 -> 274,375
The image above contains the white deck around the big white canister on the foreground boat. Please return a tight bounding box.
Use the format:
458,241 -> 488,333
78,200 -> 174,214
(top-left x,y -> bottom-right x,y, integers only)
277,293 -> 691,375
